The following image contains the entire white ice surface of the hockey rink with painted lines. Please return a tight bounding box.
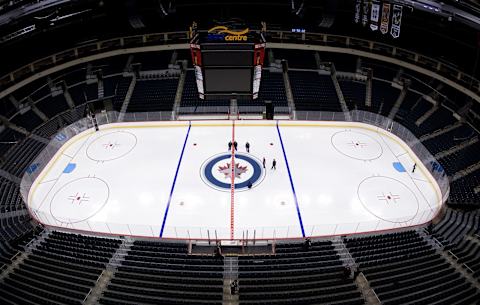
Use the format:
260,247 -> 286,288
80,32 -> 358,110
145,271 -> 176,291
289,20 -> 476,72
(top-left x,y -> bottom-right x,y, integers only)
28,120 -> 442,240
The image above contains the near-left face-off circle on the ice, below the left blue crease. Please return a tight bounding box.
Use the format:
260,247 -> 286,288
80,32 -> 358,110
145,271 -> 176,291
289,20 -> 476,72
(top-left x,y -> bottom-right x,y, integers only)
50,177 -> 110,223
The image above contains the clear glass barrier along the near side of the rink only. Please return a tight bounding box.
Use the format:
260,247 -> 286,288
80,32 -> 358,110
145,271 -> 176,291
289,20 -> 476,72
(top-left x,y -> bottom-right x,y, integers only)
24,209 -> 438,241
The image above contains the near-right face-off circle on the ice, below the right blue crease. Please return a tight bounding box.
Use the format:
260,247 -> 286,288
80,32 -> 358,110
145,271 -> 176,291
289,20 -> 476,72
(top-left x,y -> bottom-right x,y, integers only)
357,176 -> 419,223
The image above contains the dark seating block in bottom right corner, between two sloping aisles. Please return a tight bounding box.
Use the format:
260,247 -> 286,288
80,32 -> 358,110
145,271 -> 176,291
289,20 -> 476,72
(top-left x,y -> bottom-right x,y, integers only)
345,231 -> 480,304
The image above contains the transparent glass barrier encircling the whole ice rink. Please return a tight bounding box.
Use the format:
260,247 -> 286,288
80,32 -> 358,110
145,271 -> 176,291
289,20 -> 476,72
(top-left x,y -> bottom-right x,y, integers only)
20,111 -> 450,240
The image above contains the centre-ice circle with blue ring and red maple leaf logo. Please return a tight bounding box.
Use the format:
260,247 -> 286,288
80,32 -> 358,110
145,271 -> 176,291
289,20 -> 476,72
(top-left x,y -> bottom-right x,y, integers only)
200,153 -> 265,192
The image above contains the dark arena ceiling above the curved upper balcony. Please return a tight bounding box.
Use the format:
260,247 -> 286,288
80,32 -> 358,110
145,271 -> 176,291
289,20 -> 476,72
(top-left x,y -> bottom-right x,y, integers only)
0,0 -> 480,75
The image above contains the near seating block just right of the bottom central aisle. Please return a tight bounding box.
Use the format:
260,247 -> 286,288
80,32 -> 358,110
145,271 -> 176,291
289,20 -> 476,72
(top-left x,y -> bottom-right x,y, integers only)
239,241 -> 364,305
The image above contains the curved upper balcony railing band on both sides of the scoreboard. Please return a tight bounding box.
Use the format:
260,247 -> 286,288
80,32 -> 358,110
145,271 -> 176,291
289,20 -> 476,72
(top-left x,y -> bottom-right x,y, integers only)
0,30 -> 480,99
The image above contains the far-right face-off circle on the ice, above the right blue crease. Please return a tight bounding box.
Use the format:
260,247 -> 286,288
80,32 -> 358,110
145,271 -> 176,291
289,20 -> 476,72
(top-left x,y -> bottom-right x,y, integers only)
331,130 -> 383,161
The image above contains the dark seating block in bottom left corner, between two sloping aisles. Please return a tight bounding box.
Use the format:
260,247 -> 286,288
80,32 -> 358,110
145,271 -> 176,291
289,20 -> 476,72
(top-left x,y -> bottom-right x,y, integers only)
0,232 -> 121,304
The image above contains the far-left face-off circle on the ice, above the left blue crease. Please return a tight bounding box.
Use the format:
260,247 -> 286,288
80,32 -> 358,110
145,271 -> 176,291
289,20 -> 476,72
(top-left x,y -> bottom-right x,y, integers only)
86,131 -> 137,162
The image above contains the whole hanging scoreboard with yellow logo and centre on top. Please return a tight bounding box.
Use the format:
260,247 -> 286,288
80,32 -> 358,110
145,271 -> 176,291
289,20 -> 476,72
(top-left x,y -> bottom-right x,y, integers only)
190,26 -> 266,99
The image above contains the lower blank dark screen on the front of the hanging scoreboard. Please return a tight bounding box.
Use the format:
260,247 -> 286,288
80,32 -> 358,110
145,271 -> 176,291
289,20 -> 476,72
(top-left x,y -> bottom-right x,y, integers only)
205,68 -> 252,93
